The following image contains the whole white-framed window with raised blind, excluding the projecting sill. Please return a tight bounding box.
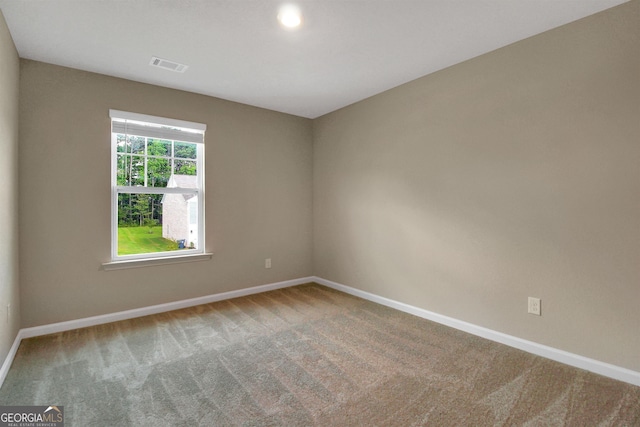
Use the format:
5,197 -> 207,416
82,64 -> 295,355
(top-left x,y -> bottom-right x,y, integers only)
109,110 -> 206,261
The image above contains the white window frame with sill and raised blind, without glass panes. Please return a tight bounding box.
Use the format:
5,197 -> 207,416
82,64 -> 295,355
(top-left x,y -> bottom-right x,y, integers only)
103,110 -> 211,269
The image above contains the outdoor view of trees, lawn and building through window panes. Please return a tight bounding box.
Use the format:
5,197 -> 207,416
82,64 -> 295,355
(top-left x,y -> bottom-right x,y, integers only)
115,134 -> 198,255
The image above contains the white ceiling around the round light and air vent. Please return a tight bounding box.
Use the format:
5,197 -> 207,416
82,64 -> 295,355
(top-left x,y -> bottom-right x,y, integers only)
0,0 -> 626,118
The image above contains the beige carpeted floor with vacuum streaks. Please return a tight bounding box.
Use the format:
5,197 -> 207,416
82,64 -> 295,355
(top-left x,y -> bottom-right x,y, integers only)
0,284 -> 640,426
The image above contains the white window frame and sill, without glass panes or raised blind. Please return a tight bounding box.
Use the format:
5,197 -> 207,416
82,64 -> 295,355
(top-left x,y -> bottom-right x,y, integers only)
102,110 -> 212,270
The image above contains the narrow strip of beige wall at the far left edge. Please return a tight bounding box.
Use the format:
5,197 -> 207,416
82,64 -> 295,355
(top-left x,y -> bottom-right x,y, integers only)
0,11 -> 20,365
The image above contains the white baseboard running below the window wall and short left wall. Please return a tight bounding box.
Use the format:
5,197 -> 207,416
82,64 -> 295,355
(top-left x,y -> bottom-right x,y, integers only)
0,277 -> 313,387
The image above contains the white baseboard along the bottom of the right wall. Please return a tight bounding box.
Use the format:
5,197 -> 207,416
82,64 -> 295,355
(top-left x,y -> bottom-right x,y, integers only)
312,277 -> 640,386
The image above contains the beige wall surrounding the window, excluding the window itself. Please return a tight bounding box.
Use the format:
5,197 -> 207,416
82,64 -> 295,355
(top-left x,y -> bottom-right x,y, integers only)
19,60 -> 312,327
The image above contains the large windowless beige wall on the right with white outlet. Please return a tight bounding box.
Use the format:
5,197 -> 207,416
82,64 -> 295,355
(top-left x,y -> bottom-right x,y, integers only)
314,1 -> 640,371
